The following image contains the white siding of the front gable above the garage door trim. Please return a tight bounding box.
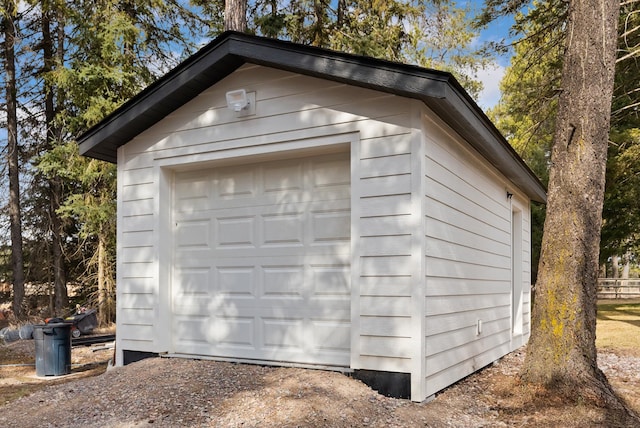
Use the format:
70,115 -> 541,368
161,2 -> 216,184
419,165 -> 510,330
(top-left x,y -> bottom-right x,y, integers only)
128,67 -> 406,158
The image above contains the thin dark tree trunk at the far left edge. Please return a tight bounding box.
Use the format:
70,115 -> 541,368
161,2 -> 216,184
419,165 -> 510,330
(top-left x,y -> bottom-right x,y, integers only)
2,0 -> 25,319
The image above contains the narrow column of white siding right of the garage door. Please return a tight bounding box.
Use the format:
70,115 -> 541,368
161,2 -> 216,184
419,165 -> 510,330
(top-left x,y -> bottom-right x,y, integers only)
352,129 -> 416,372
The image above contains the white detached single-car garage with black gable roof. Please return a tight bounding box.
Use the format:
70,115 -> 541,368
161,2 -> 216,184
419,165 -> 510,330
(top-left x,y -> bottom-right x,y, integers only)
79,32 -> 546,401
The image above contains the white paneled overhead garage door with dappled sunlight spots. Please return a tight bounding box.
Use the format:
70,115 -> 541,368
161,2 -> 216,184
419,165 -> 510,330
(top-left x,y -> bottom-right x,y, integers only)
171,154 -> 351,366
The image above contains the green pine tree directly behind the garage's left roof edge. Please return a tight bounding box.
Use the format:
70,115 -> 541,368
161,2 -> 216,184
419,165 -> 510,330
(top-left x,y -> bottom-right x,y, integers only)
37,0 -> 201,323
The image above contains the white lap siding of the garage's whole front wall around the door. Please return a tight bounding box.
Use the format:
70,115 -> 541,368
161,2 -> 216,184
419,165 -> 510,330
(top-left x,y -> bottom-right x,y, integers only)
118,66 -> 416,372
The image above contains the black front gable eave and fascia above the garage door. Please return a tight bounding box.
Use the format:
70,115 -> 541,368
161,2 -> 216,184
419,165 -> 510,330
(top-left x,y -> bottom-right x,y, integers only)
78,32 -> 449,163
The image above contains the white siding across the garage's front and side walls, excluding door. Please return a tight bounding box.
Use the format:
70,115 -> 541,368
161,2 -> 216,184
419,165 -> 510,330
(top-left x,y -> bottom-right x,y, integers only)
117,61 -> 531,400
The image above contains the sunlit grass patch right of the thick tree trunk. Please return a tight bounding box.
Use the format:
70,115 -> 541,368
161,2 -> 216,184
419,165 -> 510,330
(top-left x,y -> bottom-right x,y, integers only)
596,299 -> 640,356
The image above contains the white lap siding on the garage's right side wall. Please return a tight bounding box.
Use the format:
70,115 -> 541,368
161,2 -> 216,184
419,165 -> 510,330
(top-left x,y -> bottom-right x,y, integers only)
424,113 -> 511,396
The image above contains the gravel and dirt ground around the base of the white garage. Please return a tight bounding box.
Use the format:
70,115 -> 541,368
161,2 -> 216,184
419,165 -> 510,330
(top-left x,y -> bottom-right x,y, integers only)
0,341 -> 640,427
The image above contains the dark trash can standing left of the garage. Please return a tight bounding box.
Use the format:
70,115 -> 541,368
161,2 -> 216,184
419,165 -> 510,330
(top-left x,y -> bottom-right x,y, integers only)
33,323 -> 71,376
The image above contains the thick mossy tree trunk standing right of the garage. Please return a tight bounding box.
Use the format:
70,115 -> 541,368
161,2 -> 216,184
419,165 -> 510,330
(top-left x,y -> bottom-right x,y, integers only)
521,0 -> 620,405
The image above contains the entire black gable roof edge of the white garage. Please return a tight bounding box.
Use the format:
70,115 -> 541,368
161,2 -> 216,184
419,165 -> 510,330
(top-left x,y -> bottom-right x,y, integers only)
78,31 -> 546,202
